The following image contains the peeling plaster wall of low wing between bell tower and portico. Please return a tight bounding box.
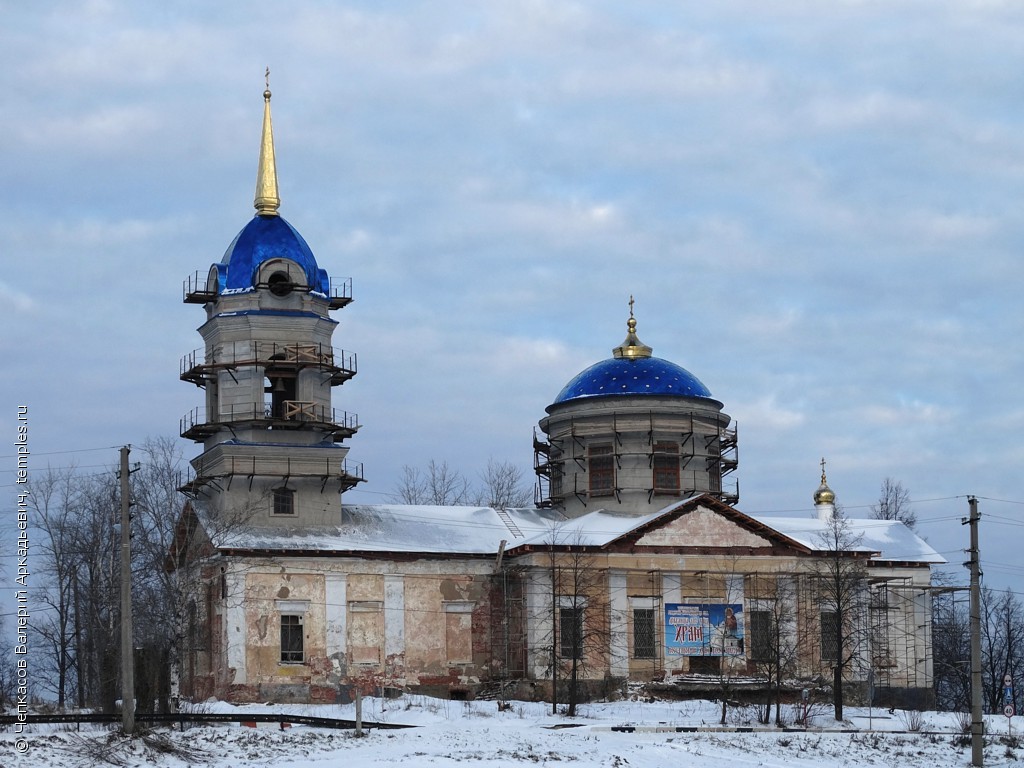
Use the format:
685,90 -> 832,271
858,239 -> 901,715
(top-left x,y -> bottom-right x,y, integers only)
213,558 -> 493,700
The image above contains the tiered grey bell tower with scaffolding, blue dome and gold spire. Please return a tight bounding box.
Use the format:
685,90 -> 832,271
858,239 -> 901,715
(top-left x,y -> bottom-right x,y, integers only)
180,85 -> 364,527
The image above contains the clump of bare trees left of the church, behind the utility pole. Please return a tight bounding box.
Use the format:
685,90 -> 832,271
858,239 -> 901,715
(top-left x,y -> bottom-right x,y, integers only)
29,437 -> 265,712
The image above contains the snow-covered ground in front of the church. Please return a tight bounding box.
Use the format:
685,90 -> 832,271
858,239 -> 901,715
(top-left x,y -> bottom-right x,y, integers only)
0,696 -> 1024,768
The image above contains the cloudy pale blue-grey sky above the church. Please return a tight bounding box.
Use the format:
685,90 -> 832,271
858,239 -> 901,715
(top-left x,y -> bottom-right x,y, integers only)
0,0 -> 1024,586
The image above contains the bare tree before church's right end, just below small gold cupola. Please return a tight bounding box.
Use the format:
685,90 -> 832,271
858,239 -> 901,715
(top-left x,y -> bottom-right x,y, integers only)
813,509 -> 867,721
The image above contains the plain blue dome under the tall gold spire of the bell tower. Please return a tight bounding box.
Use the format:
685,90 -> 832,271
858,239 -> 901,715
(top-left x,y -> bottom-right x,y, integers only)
216,215 -> 331,296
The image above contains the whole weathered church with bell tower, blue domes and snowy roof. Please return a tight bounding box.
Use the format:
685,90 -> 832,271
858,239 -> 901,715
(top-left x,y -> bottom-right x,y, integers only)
168,85 -> 943,701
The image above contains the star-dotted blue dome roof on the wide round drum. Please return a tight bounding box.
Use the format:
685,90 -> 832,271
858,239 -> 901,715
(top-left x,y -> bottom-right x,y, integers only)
555,357 -> 711,403
